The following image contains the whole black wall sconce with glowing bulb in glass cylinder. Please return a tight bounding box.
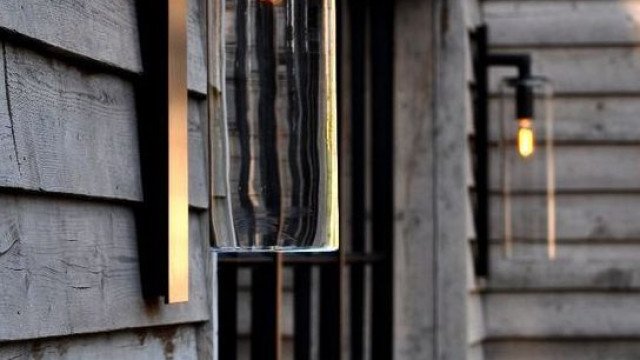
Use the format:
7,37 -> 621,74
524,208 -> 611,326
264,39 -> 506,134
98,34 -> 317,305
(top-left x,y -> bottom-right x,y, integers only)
472,26 -> 556,276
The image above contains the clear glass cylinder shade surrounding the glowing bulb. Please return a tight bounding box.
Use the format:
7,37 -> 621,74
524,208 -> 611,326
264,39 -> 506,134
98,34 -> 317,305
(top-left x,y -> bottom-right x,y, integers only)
494,77 -> 557,259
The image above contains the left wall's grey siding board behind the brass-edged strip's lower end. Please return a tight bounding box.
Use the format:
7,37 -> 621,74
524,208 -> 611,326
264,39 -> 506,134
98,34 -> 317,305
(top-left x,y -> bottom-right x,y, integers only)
0,195 -> 209,342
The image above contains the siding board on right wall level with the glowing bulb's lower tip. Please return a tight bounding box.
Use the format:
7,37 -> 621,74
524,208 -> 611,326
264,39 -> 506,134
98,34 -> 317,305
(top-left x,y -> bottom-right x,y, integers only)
490,144 -> 640,196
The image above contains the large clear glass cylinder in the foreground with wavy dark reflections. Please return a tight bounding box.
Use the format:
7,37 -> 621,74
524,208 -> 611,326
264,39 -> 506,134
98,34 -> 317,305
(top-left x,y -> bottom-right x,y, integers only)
213,0 -> 338,252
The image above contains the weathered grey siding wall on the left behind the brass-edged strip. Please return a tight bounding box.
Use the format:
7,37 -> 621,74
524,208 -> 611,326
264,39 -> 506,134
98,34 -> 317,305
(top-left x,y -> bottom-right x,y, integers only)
0,0 -> 215,359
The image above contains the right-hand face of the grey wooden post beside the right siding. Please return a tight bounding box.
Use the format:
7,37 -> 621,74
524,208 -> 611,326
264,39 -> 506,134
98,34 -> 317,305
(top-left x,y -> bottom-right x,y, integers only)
432,1 -> 472,360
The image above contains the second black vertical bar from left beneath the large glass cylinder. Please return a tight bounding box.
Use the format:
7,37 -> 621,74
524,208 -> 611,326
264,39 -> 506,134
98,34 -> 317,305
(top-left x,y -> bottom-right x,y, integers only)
251,254 -> 282,360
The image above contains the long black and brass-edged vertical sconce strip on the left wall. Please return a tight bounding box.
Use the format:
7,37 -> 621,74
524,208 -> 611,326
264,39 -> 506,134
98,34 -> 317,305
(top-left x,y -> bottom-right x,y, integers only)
136,0 -> 189,303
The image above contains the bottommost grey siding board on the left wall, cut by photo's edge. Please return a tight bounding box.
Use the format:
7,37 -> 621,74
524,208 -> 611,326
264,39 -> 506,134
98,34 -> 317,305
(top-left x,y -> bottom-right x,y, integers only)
0,325 -> 200,360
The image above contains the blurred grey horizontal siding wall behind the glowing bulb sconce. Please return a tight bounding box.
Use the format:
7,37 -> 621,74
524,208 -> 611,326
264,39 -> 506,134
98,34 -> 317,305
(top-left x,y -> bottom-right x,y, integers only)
478,0 -> 640,360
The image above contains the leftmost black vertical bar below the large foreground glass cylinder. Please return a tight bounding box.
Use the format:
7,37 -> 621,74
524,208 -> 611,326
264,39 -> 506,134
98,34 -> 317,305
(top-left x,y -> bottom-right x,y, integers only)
218,262 -> 238,360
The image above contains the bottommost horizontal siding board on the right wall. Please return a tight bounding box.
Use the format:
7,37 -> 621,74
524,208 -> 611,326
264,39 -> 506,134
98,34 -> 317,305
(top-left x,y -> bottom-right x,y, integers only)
484,339 -> 640,360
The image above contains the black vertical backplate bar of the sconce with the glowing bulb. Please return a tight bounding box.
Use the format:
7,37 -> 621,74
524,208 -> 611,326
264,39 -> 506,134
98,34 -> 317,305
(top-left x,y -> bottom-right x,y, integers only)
474,25 -> 490,276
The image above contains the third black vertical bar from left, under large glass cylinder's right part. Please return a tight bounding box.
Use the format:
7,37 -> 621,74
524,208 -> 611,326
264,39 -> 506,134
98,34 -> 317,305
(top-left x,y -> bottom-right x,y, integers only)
293,264 -> 311,360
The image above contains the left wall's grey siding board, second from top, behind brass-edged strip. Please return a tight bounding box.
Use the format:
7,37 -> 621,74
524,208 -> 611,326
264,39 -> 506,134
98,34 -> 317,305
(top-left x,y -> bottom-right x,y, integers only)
0,44 -> 208,208
